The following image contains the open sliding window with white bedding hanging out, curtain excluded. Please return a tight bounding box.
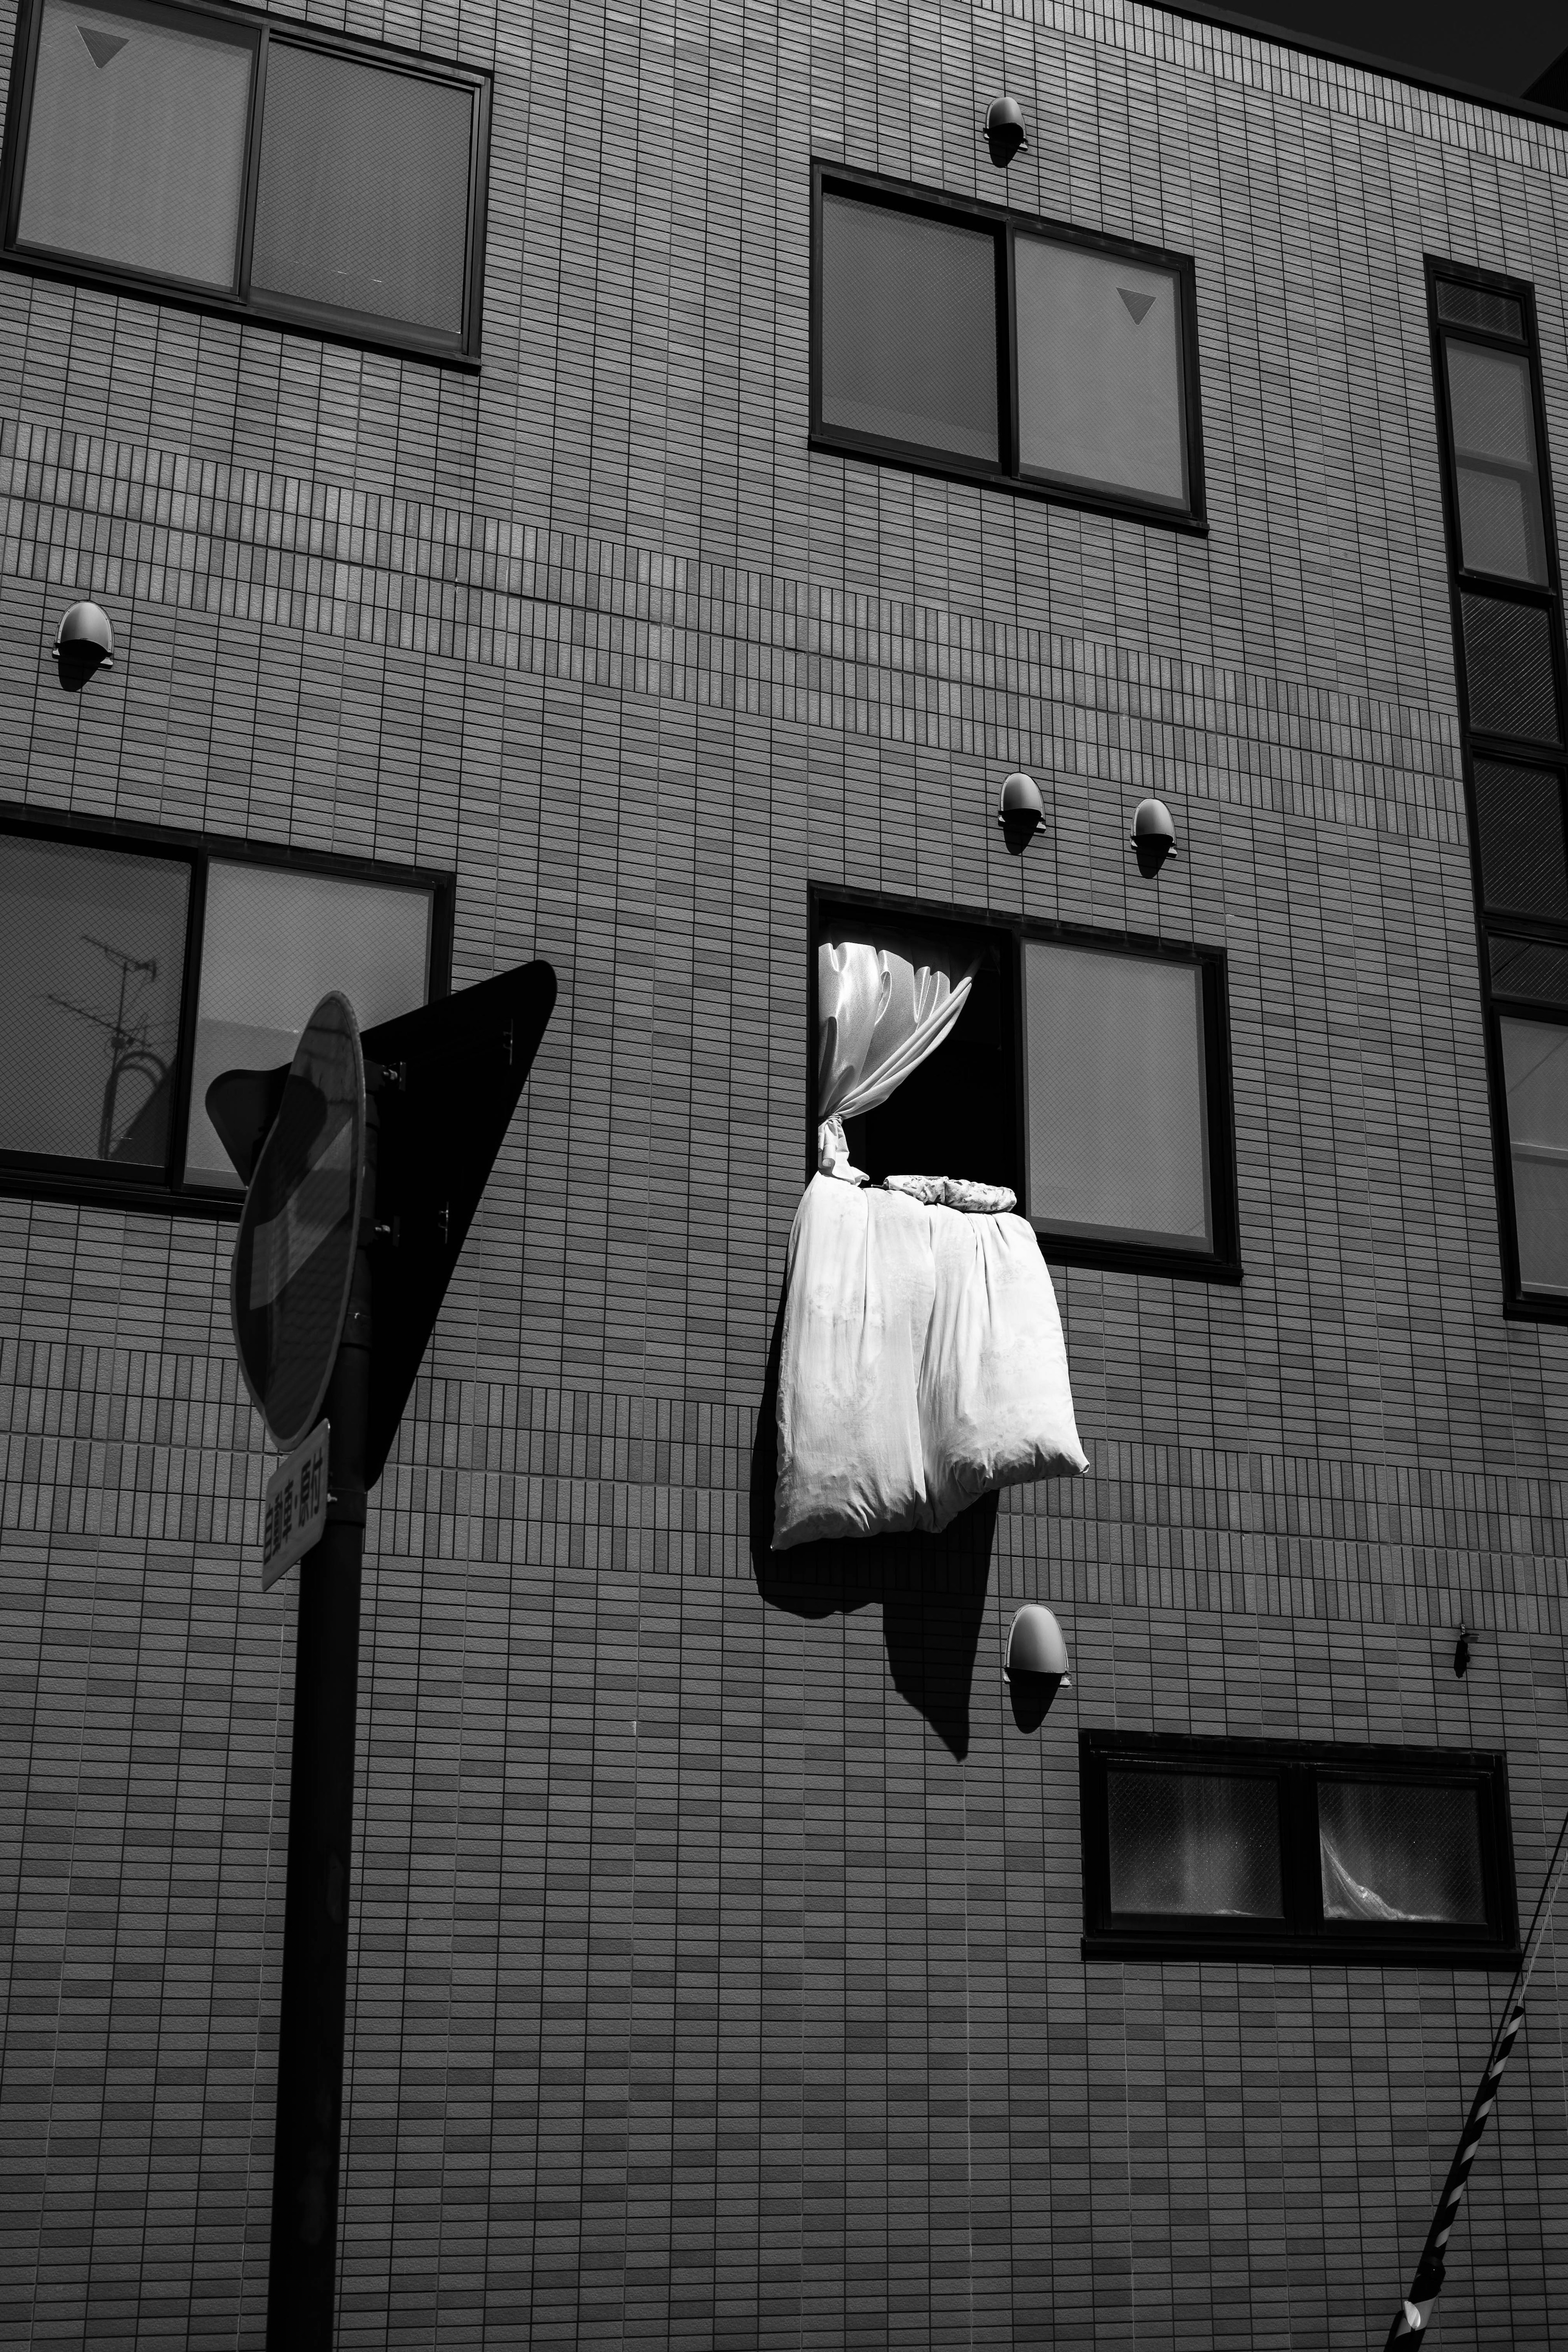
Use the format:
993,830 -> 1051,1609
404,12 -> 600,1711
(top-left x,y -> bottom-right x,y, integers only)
811,894 -> 1241,1282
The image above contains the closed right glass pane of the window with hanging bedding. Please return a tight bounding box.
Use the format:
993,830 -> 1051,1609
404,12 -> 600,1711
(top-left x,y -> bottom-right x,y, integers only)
1022,941 -> 1213,1251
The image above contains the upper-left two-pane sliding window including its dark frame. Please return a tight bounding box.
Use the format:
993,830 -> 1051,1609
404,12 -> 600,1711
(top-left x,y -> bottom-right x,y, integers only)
5,0 -> 489,360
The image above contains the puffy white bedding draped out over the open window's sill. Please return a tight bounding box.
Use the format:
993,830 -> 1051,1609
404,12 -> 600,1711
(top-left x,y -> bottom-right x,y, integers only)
773,1176 -> 1089,1552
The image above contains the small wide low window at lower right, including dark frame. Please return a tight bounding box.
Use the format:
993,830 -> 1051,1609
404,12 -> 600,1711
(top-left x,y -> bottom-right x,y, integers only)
1079,1731 -> 1519,1966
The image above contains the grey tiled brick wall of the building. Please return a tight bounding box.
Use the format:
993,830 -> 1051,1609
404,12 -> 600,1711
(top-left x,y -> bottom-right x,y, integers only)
0,0 -> 1568,2352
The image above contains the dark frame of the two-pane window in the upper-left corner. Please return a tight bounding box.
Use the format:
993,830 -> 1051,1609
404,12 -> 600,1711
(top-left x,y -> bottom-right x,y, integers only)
0,0 -> 491,372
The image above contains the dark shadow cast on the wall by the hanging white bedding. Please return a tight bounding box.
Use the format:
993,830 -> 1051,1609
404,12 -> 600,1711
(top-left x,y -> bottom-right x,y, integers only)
750,1301 -> 997,1759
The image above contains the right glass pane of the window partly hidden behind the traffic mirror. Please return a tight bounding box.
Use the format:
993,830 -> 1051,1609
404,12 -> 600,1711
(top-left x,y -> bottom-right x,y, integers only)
186,858 -> 430,1190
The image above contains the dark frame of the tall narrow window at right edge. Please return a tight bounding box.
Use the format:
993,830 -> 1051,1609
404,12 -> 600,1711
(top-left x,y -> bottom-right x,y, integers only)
1425,254 -> 1568,1324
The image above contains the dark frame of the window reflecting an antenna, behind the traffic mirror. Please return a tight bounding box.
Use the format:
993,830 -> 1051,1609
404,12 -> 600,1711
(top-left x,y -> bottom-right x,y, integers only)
0,802 -> 456,1218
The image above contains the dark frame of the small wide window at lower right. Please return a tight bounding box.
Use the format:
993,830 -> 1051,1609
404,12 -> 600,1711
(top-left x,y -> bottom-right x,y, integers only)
1079,1731 -> 1519,1969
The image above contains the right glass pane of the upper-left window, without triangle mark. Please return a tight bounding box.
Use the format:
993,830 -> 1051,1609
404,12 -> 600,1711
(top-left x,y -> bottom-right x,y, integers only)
252,38 -> 475,339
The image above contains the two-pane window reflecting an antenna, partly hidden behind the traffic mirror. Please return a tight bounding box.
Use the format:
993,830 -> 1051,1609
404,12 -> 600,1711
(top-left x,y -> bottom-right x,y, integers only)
0,811 -> 451,1214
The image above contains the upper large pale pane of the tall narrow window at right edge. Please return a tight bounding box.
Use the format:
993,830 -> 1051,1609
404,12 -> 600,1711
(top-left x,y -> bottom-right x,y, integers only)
1448,336 -> 1547,586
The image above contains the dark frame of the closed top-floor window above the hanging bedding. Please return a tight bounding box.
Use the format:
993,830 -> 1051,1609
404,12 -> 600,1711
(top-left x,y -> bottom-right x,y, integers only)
806,158 -> 1208,539
